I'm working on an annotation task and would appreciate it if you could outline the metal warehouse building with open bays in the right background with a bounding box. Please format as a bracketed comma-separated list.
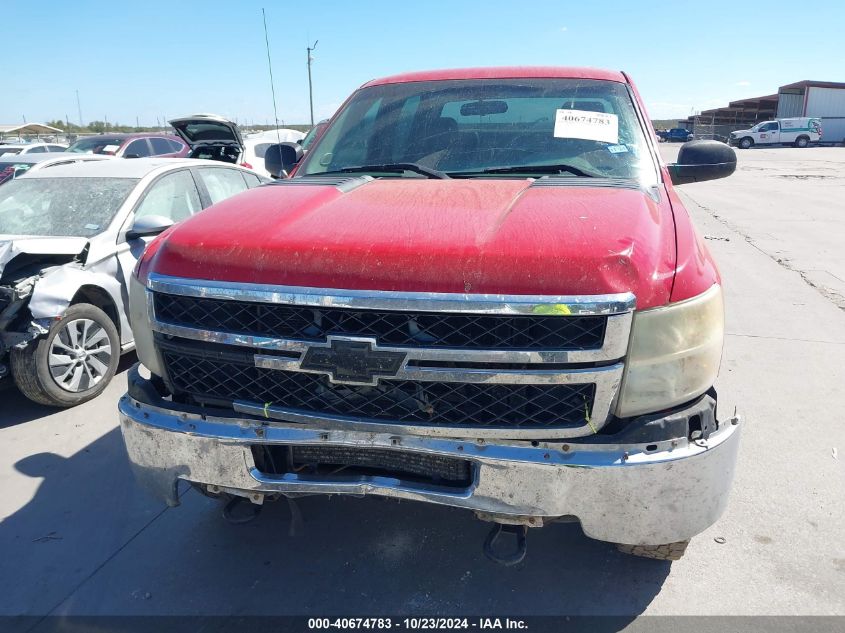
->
[678, 80, 845, 143]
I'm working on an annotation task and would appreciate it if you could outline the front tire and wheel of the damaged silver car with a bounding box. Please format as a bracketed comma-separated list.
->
[11, 303, 120, 407]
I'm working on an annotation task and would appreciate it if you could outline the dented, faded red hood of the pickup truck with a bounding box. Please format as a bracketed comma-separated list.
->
[150, 177, 675, 309]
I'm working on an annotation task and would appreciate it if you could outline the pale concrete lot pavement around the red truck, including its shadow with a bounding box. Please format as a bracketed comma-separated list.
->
[0, 147, 845, 616]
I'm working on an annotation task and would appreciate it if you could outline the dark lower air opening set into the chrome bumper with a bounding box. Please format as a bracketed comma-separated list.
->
[252, 444, 473, 487]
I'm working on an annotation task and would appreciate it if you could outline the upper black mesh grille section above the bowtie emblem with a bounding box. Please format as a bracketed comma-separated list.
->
[150, 293, 606, 350]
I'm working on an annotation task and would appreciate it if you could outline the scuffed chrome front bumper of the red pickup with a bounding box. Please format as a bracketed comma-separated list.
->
[119, 376, 740, 545]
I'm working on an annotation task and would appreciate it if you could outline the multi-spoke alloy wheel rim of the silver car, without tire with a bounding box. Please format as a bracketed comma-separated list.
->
[48, 319, 112, 393]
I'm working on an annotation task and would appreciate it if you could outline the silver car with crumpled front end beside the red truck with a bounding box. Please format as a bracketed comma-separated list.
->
[0, 158, 266, 407]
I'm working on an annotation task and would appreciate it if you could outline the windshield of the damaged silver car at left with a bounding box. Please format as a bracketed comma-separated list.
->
[0, 178, 138, 237]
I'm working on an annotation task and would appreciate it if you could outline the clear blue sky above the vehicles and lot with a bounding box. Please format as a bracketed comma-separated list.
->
[0, 0, 845, 125]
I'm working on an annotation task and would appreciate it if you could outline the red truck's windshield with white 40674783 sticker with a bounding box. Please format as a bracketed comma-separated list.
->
[297, 79, 657, 183]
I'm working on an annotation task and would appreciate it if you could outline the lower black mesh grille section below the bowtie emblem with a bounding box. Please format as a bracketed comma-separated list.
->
[162, 344, 595, 429]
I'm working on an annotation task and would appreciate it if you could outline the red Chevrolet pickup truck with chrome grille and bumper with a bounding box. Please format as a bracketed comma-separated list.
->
[119, 67, 740, 564]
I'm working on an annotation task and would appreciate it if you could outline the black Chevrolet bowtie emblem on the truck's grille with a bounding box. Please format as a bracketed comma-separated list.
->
[299, 338, 405, 385]
